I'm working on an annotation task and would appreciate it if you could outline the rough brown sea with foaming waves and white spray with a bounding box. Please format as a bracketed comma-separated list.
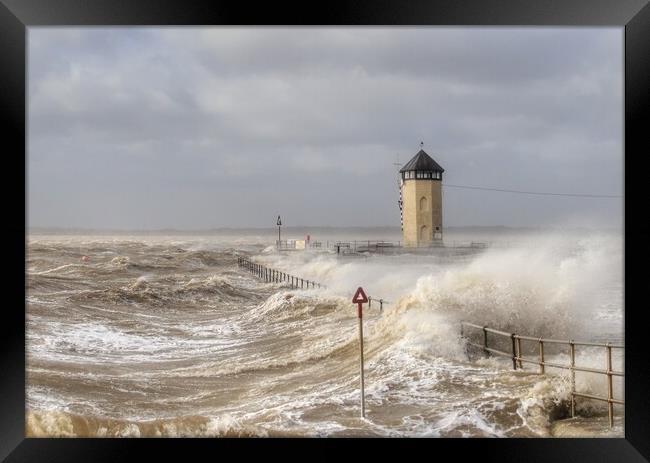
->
[27, 236, 623, 437]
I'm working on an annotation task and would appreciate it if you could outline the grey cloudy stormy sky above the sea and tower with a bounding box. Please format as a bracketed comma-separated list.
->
[27, 27, 623, 229]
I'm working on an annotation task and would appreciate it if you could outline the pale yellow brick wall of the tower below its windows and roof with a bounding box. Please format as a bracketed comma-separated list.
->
[402, 179, 442, 246]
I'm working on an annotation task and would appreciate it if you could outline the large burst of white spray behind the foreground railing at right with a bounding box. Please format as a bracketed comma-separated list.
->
[388, 234, 621, 336]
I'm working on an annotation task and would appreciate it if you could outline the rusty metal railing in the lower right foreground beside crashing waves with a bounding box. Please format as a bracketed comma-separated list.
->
[460, 321, 625, 428]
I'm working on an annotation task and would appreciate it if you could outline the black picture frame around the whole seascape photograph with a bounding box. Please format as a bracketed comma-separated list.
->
[0, 0, 650, 462]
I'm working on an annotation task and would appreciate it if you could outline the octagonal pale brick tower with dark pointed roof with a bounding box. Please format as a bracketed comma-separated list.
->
[400, 149, 445, 246]
